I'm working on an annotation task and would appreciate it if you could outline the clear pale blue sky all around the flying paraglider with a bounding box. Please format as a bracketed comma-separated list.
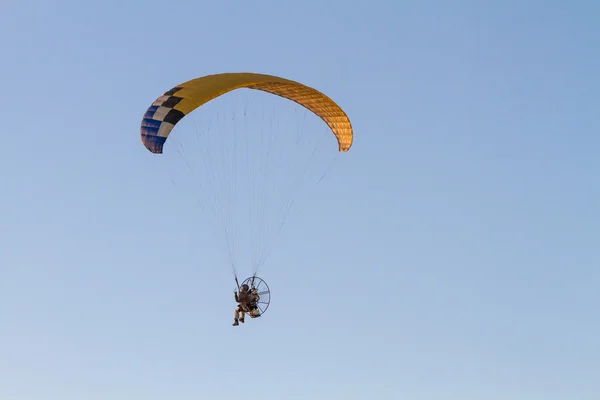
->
[0, 0, 600, 400]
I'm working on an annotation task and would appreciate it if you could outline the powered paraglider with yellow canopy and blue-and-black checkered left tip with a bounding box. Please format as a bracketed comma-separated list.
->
[140, 73, 353, 314]
